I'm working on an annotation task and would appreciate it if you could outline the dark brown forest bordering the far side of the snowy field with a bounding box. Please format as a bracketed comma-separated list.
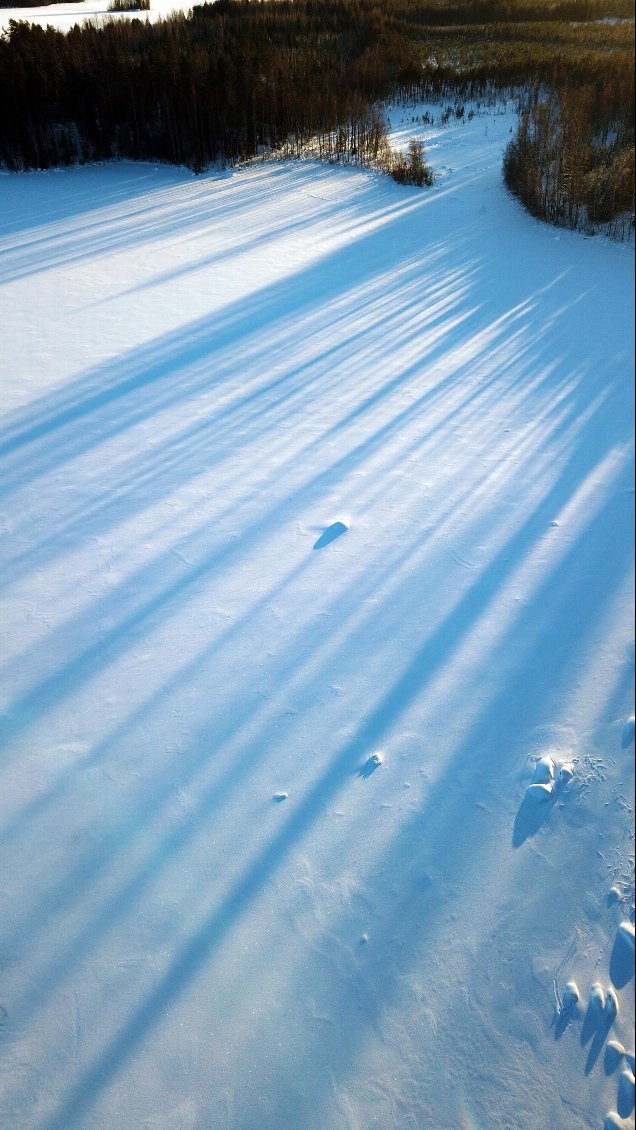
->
[0, 0, 634, 236]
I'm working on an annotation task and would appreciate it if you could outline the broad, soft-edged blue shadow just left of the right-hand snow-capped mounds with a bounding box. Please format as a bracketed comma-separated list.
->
[245, 467, 629, 1127]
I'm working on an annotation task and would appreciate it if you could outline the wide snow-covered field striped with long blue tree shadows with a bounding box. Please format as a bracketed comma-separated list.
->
[0, 101, 634, 1130]
